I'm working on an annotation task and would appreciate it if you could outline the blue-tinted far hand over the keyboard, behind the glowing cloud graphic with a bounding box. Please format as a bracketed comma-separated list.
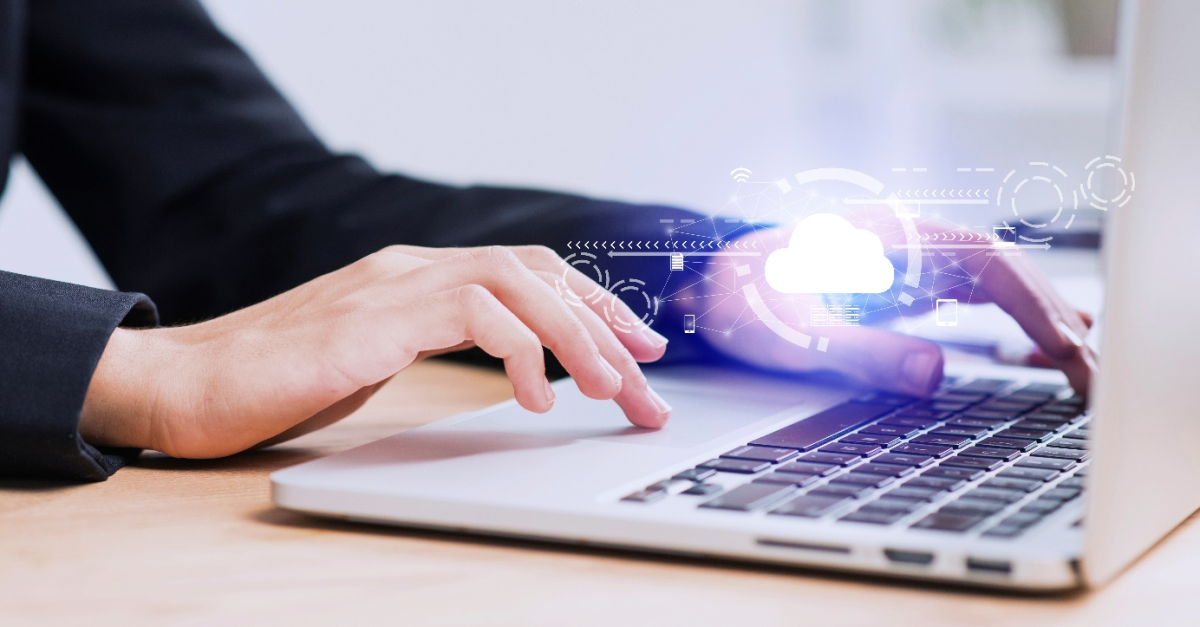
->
[692, 211, 1092, 396]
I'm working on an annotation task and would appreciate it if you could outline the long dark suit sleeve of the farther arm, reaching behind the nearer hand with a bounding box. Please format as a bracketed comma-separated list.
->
[22, 0, 691, 323]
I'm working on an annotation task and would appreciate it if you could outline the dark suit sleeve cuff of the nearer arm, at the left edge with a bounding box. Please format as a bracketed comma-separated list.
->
[0, 271, 156, 480]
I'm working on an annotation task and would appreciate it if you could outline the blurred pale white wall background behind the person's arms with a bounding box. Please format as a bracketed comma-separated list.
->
[0, 0, 1110, 285]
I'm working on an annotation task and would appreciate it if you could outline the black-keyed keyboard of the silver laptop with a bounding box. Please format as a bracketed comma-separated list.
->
[623, 378, 1090, 538]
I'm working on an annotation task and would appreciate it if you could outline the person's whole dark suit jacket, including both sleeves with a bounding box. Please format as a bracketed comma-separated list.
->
[0, 0, 691, 480]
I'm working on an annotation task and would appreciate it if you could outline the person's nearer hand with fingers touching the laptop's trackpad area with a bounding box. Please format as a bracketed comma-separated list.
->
[79, 246, 671, 458]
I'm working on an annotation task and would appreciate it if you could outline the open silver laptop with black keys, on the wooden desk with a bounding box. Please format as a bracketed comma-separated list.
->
[271, 1, 1200, 591]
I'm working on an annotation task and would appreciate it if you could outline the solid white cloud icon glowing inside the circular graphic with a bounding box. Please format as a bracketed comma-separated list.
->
[767, 214, 895, 294]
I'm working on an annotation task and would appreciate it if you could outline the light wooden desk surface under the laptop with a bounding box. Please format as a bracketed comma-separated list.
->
[0, 363, 1200, 626]
